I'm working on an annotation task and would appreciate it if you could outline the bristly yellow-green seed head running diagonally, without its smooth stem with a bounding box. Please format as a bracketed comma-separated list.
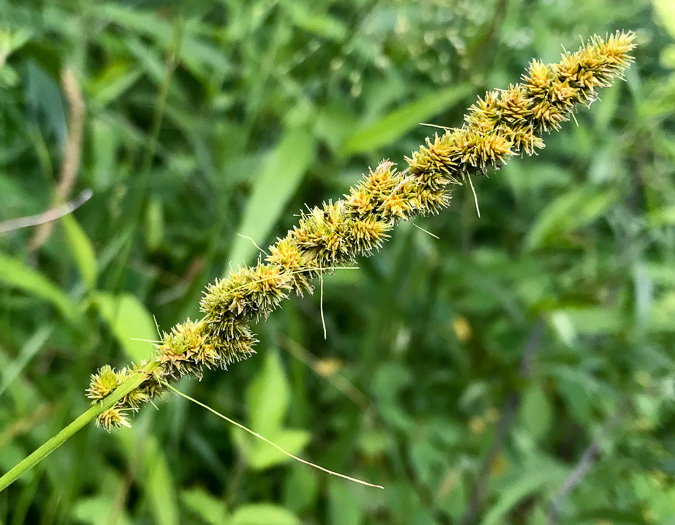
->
[87, 33, 634, 430]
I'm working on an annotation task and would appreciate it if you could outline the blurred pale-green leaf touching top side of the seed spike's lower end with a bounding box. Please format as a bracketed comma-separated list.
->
[94, 292, 159, 363]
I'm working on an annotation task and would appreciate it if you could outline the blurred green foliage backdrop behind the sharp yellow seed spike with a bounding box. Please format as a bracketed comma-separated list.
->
[0, 0, 675, 525]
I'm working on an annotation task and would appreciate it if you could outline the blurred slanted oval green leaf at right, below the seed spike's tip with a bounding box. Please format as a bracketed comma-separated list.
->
[527, 187, 617, 249]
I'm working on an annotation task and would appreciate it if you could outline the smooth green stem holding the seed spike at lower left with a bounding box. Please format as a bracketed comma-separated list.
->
[0, 362, 159, 492]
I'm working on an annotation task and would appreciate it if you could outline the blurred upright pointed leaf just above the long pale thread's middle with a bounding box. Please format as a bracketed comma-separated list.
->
[246, 350, 290, 439]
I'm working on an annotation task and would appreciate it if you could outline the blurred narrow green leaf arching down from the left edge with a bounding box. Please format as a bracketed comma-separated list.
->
[0, 253, 80, 324]
